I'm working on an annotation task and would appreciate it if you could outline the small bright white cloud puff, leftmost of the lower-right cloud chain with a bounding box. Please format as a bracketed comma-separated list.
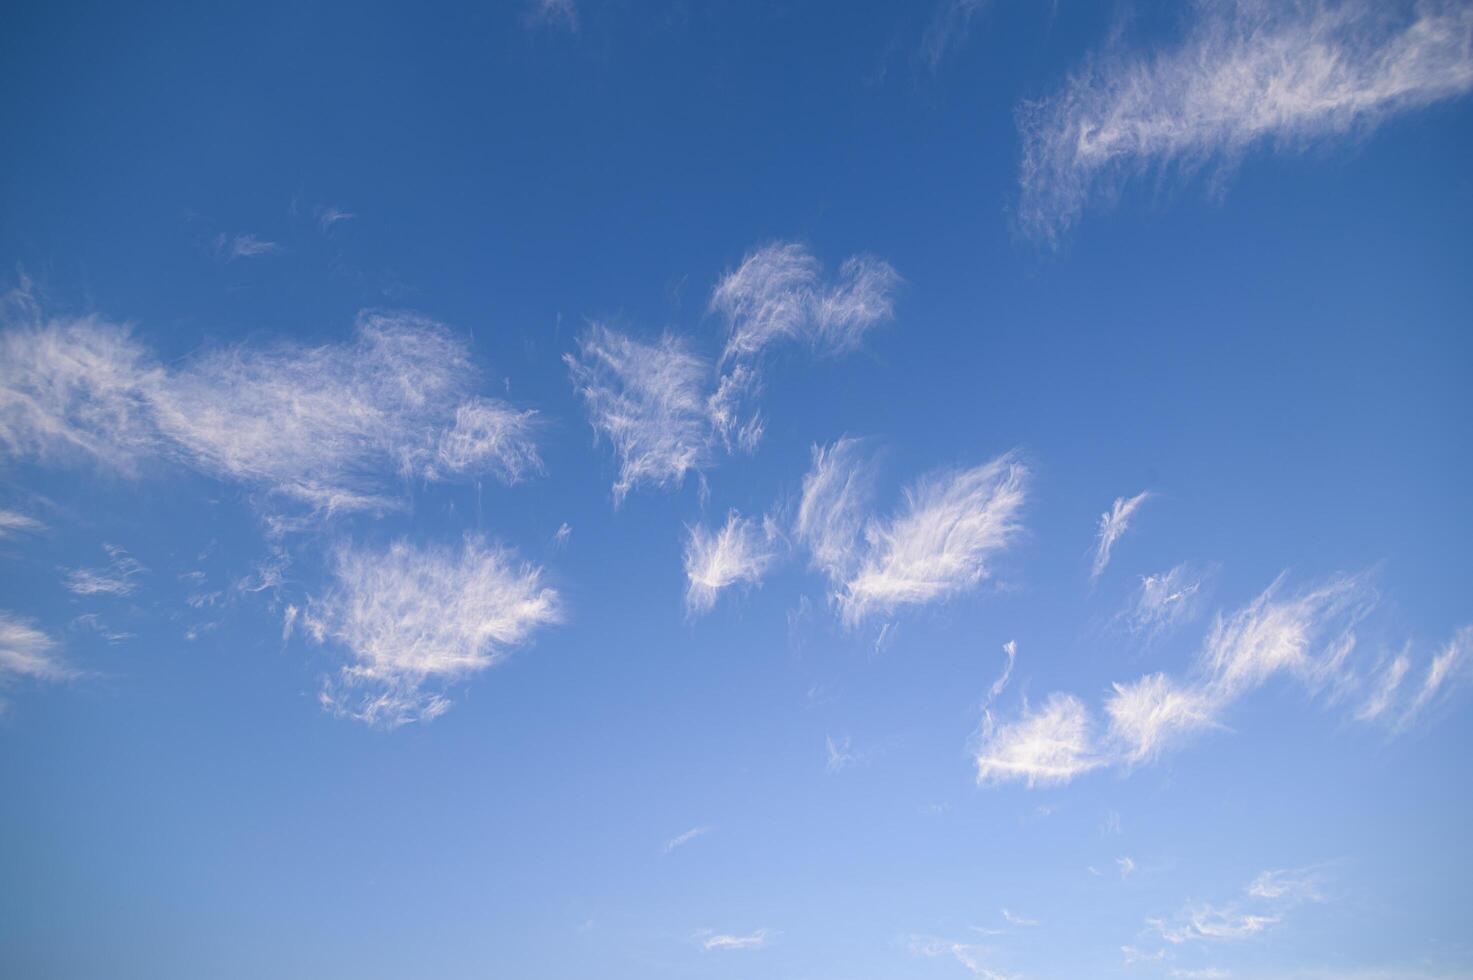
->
[977, 694, 1103, 787]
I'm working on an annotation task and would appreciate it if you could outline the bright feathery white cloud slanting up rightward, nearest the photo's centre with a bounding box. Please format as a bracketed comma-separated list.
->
[837, 454, 1028, 623]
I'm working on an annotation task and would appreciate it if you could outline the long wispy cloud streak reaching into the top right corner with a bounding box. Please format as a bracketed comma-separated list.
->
[1019, 0, 1473, 240]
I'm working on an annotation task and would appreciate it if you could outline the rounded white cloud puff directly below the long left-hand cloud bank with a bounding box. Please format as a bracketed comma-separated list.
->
[303, 536, 563, 728]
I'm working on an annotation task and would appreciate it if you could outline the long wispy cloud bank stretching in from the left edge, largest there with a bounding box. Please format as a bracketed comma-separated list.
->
[0, 300, 541, 513]
